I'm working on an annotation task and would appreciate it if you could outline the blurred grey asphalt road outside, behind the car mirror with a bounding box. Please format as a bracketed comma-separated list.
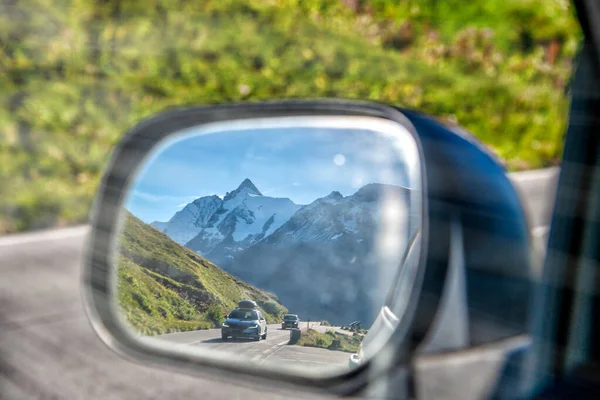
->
[0, 170, 556, 400]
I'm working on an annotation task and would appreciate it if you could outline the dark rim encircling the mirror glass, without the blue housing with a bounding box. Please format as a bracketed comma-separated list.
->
[83, 100, 427, 394]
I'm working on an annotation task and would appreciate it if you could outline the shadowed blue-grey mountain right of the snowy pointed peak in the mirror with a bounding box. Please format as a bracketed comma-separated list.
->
[227, 184, 408, 326]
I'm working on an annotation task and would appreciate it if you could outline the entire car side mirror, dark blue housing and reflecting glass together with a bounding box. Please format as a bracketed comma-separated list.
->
[84, 100, 531, 394]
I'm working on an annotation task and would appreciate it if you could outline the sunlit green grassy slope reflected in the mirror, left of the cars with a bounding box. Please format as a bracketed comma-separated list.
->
[118, 211, 287, 335]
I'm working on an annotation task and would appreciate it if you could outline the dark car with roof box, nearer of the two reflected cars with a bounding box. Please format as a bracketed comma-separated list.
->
[221, 308, 267, 340]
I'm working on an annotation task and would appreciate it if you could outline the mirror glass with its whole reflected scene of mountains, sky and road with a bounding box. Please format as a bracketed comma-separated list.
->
[116, 117, 422, 373]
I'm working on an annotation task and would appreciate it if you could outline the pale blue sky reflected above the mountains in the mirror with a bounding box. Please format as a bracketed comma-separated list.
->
[125, 122, 418, 223]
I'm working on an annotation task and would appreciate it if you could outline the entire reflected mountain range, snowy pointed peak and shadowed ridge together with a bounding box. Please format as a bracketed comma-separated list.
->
[153, 179, 414, 324]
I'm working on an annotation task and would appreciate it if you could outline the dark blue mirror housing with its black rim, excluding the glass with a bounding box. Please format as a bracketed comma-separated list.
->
[84, 100, 531, 394]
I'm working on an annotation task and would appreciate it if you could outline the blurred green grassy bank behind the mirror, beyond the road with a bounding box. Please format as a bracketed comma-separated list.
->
[0, 0, 581, 233]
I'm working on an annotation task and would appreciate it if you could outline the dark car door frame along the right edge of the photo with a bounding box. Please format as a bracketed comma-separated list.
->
[527, 0, 600, 398]
